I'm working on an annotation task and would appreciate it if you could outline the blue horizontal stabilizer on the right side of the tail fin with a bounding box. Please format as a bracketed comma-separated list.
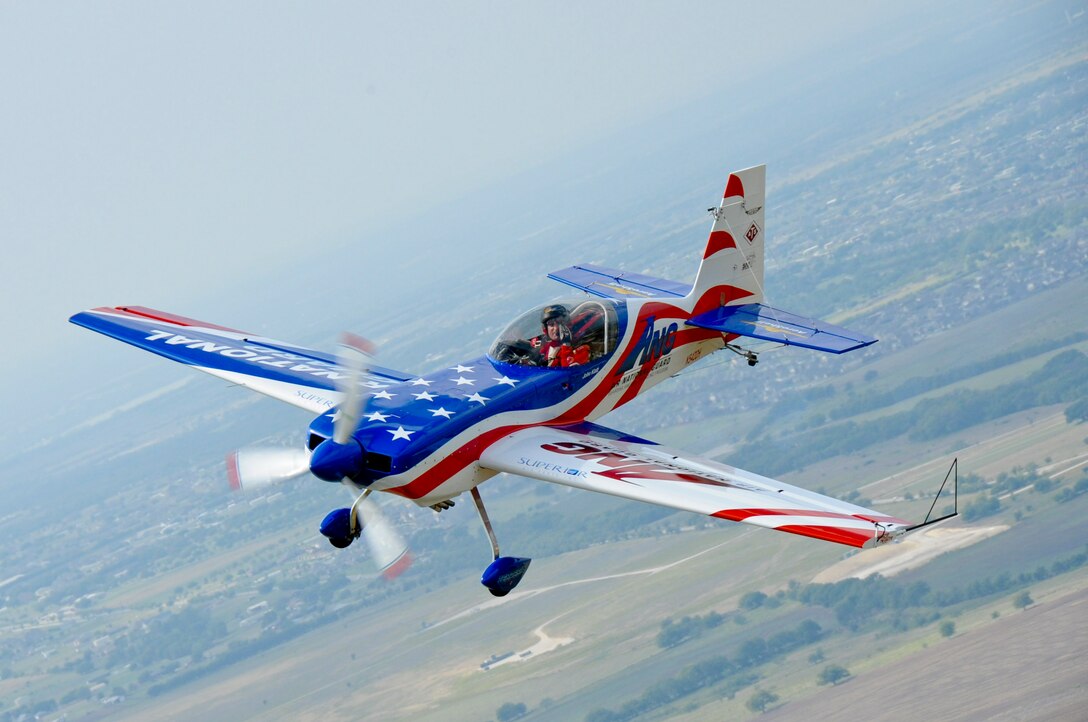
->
[688, 303, 877, 353]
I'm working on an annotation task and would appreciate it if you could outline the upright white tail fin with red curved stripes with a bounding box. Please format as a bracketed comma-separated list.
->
[688, 165, 767, 313]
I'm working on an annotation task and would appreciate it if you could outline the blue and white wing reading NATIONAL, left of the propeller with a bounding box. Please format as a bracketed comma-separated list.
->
[70, 306, 412, 413]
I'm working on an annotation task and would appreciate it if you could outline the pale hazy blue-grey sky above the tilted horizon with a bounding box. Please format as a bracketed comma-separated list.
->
[0, 0, 948, 377]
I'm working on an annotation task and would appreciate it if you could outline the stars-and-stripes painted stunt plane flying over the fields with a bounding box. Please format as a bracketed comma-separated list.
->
[71, 165, 931, 596]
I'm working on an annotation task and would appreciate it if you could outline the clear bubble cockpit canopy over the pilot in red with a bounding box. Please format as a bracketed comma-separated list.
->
[487, 298, 623, 369]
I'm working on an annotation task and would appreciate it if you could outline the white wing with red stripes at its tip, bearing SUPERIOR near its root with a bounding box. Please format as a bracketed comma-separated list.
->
[480, 424, 911, 547]
